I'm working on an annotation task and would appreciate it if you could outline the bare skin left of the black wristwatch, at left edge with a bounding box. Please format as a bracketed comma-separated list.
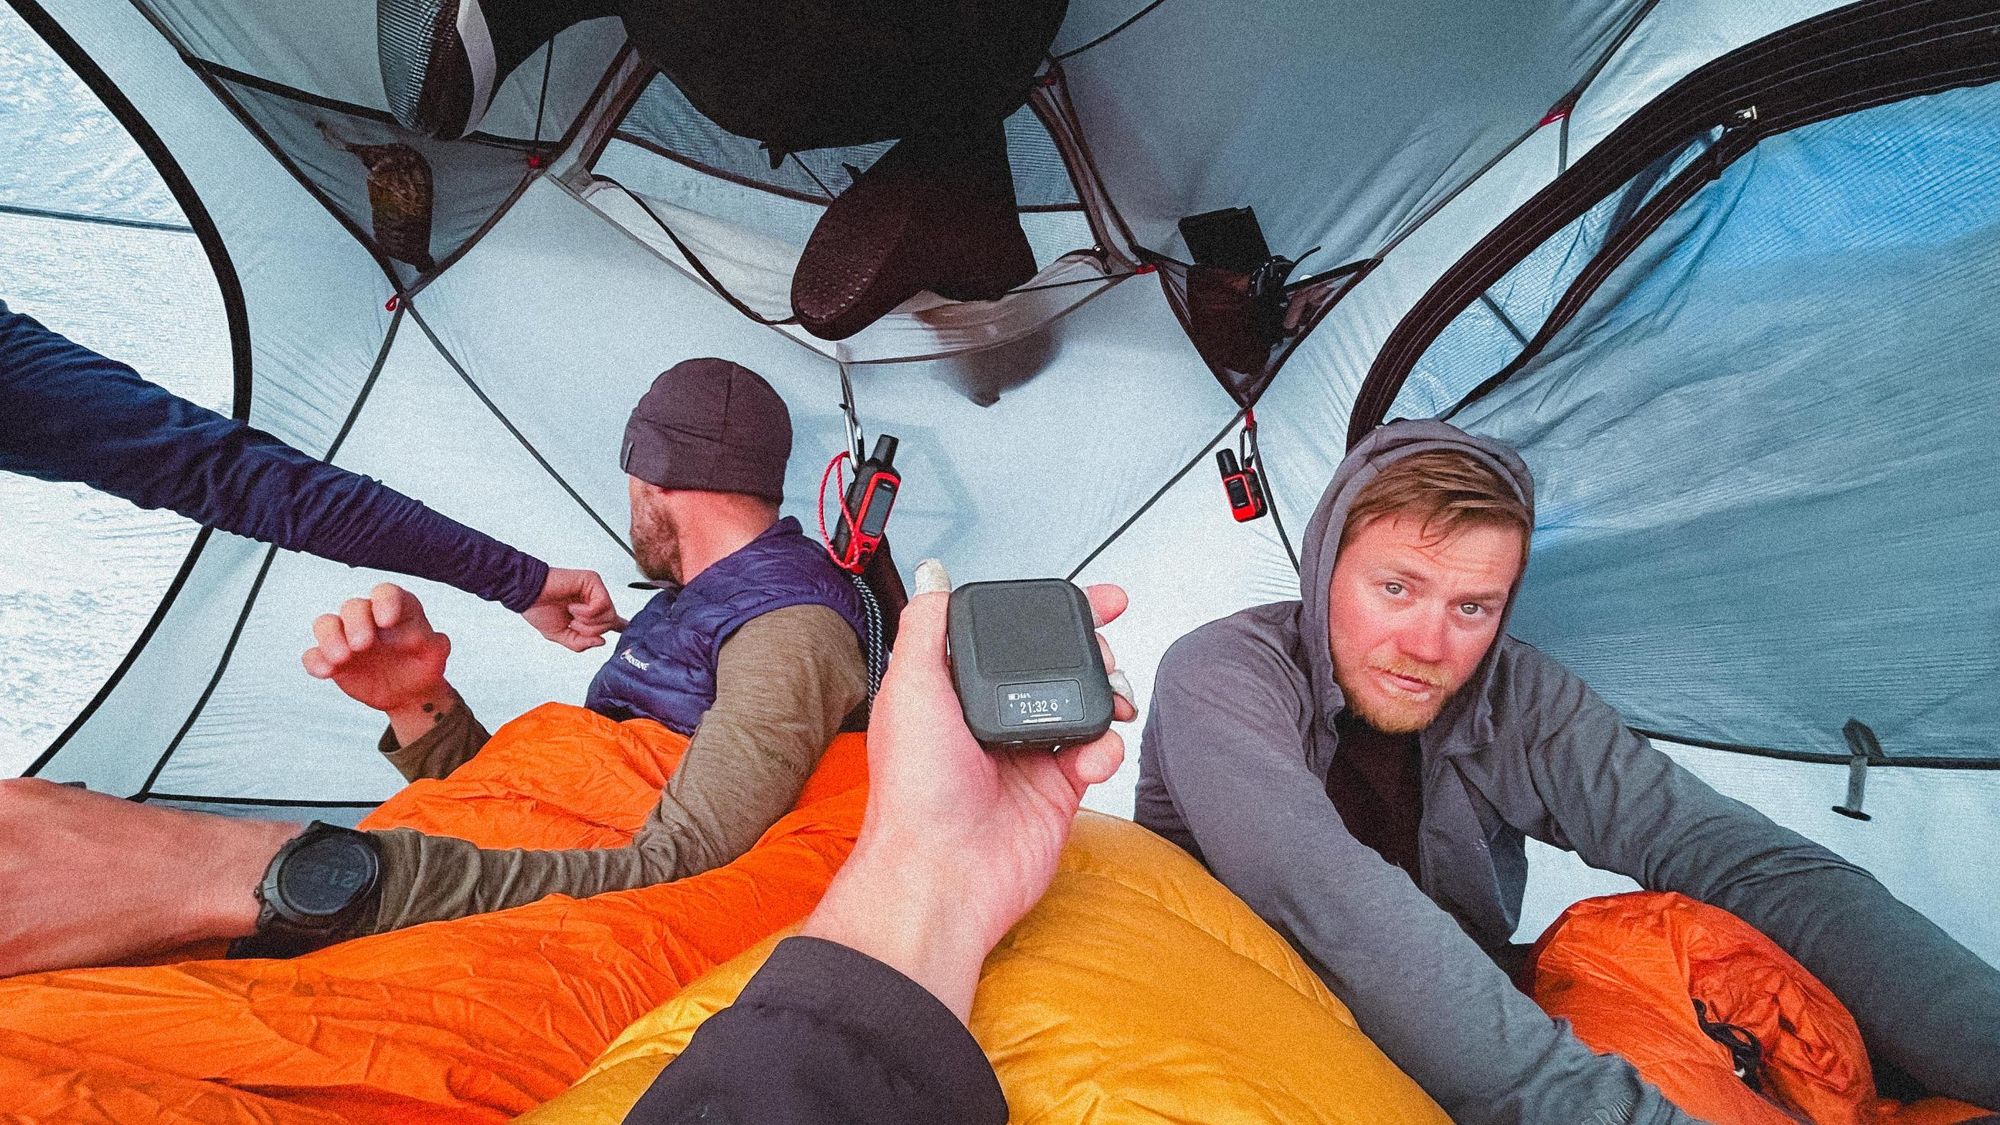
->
[0, 779, 302, 977]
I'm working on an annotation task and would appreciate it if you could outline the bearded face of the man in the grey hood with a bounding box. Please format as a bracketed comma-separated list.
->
[1326, 514, 1522, 735]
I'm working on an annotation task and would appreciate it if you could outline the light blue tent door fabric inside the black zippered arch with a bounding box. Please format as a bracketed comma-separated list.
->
[1394, 86, 2000, 763]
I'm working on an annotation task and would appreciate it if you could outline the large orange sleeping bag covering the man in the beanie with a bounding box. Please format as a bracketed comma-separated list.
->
[0, 705, 868, 1125]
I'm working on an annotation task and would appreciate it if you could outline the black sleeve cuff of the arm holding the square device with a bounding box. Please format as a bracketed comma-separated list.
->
[626, 937, 1008, 1125]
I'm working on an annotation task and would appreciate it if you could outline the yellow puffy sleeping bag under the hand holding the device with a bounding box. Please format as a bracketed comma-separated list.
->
[520, 813, 1450, 1125]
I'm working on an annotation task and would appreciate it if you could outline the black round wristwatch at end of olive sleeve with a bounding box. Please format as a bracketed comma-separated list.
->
[230, 821, 382, 957]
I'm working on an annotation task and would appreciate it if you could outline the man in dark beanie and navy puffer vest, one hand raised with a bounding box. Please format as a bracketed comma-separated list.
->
[292, 358, 868, 937]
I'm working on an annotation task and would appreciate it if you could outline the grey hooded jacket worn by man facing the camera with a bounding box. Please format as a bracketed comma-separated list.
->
[1136, 420, 2000, 1125]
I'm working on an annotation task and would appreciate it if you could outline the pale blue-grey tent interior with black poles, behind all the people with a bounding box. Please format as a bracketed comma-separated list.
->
[0, 0, 2000, 961]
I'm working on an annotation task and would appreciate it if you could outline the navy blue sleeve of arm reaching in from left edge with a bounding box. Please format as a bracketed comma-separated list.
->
[0, 302, 548, 613]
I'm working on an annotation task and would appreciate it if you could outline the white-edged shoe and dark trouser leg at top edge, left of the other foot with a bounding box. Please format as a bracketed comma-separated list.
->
[376, 0, 614, 140]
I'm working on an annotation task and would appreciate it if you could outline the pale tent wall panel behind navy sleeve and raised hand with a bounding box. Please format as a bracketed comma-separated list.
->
[148, 318, 636, 807]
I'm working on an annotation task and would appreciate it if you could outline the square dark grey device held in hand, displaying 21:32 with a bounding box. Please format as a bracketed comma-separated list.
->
[946, 579, 1112, 751]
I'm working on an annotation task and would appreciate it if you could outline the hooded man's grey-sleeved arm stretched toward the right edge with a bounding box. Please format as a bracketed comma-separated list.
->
[1530, 656, 2000, 1109]
